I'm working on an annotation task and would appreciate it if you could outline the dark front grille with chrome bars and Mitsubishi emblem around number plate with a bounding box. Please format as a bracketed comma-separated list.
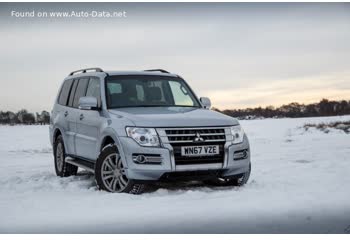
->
[165, 128, 226, 165]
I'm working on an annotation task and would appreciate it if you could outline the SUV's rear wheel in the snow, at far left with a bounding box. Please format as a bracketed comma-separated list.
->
[54, 135, 78, 177]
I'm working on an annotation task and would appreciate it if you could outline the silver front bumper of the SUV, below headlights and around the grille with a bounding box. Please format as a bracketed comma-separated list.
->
[120, 136, 250, 181]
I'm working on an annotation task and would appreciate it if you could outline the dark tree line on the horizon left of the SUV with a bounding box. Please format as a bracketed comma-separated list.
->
[0, 109, 50, 125]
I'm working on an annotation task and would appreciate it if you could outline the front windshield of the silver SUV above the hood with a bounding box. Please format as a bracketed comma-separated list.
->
[106, 75, 200, 108]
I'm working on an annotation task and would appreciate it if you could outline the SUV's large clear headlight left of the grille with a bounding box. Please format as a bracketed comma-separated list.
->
[126, 127, 159, 147]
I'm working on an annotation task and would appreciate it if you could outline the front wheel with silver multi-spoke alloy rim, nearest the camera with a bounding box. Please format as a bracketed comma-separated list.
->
[95, 145, 146, 194]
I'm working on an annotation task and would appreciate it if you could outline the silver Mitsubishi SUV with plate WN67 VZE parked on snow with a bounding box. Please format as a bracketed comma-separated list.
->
[50, 68, 251, 194]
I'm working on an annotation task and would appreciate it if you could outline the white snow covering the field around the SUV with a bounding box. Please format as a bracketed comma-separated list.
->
[0, 116, 350, 233]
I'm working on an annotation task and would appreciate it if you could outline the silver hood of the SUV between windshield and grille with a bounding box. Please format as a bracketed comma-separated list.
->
[109, 107, 238, 127]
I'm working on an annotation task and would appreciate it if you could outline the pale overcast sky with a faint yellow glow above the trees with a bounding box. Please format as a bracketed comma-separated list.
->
[0, 3, 350, 111]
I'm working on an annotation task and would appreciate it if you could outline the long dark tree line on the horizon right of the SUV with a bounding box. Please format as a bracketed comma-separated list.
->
[213, 99, 350, 119]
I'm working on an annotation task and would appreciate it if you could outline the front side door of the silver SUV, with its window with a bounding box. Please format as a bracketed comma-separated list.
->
[76, 77, 103, 160]
